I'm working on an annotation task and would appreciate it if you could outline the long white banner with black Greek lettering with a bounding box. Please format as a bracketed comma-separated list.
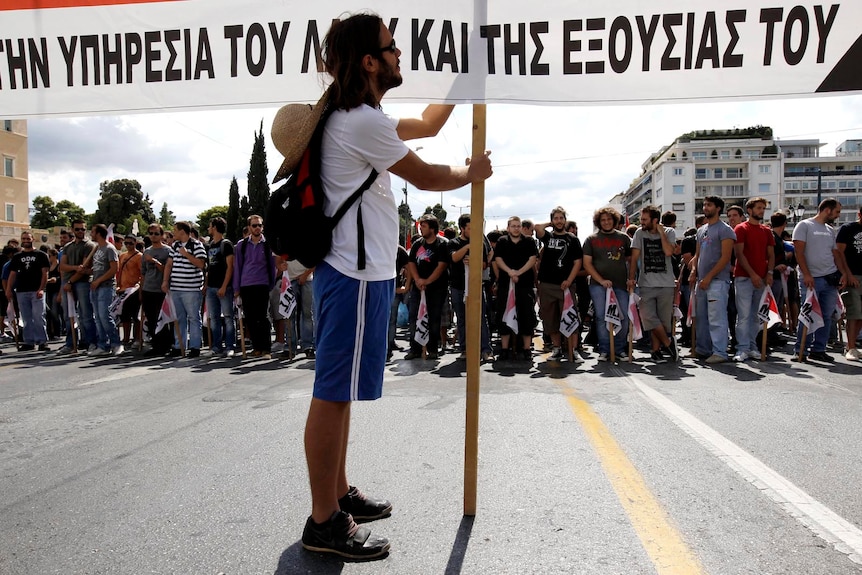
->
[0, 0, 862, 118]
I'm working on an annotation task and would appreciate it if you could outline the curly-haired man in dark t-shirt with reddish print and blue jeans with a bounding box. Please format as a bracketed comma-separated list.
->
[584, 207, 631, 361]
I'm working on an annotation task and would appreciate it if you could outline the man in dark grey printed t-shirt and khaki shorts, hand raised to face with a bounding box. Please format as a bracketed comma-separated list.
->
[628, 206, 679, 363]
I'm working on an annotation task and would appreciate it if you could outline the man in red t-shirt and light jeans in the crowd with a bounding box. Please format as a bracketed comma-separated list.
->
[733, 198, 775, 362]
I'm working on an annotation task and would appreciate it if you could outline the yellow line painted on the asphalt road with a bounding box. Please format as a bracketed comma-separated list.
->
[558, 381, 706, 575]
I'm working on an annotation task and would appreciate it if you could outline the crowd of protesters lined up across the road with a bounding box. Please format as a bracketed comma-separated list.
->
[0, 196, 862, 364]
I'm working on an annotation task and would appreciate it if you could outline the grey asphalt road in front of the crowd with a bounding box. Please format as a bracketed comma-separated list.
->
[0, 338, 862, 575]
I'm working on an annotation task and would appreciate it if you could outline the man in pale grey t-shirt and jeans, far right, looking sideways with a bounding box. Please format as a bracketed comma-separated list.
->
[793, 198, 848, 361]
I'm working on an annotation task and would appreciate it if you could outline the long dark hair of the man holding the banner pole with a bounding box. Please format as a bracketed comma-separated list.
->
[321, 14, 382, 110]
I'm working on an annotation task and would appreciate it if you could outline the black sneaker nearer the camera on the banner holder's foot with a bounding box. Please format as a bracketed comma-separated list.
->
[302, 511, 389, 559]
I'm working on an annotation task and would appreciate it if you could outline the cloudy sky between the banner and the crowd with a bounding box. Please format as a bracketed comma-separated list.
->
[28, 95, 862, 230]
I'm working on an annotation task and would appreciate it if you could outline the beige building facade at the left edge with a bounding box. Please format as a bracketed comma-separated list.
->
[0, 120, 30, 245]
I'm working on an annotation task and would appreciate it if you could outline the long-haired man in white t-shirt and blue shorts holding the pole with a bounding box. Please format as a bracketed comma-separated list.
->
[273, 14, 491, 559]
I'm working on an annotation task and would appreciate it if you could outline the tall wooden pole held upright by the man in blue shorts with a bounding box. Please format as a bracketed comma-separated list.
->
[464, 104, 487, 516]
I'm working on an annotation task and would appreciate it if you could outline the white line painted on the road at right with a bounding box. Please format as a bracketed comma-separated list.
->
[629, 376, 862, 563]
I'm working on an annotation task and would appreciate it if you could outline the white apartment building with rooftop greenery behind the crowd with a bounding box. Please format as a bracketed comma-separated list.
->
[622, 126, 862, 230]
